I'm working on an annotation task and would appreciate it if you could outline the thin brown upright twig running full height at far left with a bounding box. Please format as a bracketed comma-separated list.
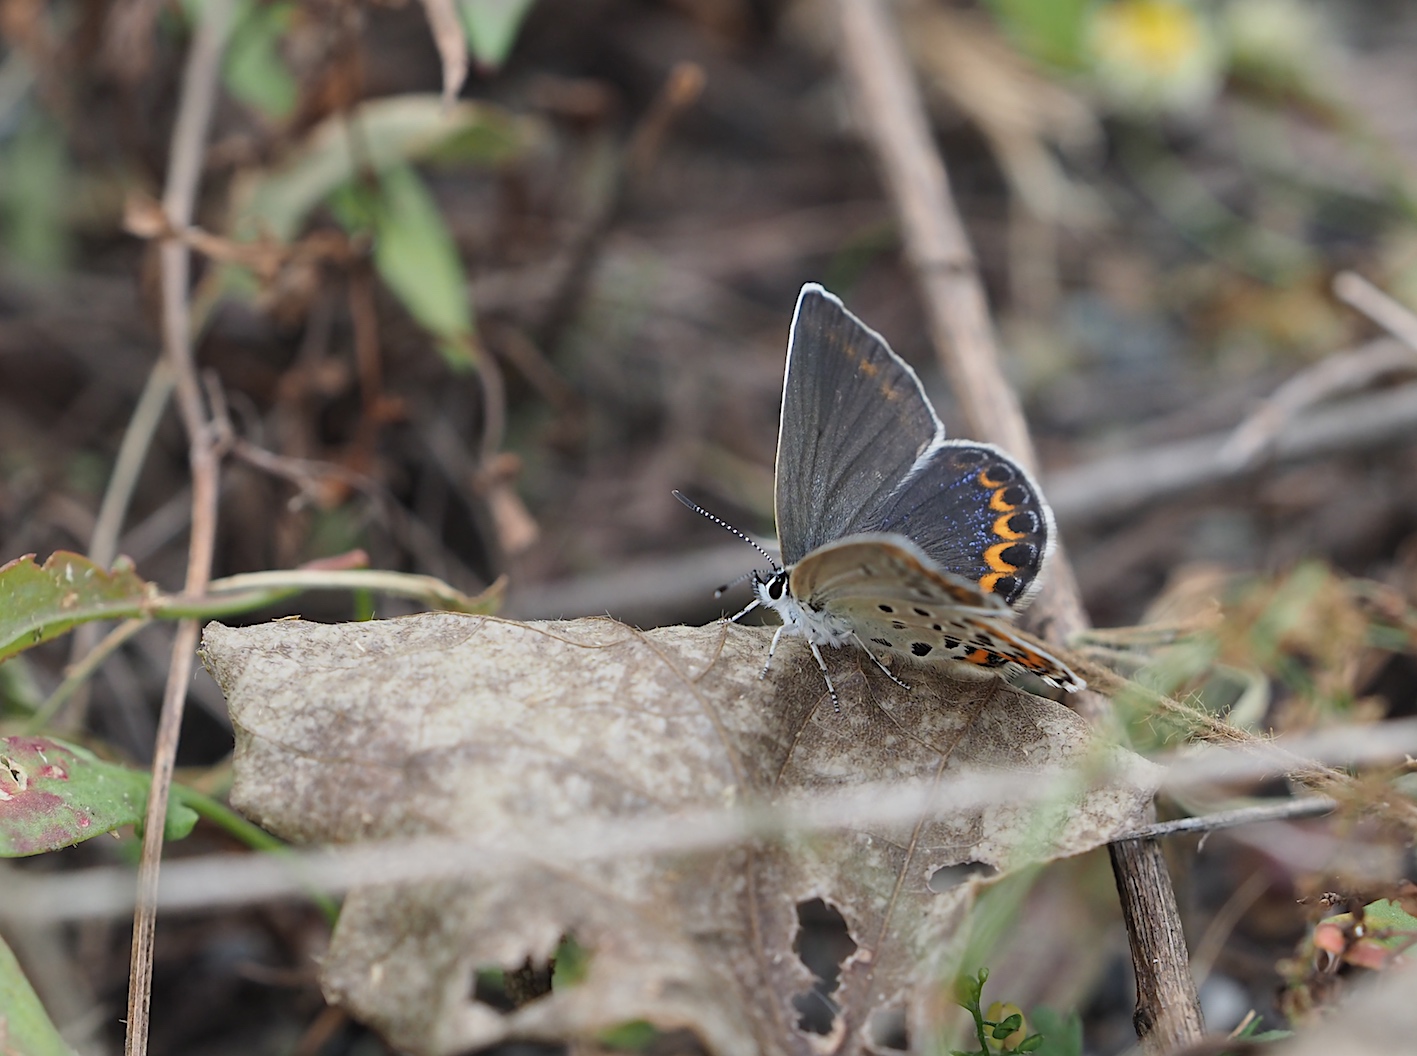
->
[123, 0, 234, 1056]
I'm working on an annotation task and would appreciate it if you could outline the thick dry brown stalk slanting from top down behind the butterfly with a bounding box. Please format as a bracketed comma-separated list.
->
[836, 0, 1204, 1052]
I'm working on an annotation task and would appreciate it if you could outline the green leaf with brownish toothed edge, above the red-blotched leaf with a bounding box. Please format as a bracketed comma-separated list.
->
[0, 550, 156, 661]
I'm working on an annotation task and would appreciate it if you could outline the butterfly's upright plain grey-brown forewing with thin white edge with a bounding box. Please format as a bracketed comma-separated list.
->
[775, 283, 944, 564]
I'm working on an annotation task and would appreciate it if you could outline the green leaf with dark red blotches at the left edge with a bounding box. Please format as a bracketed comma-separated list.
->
[0, 737, 197, 858]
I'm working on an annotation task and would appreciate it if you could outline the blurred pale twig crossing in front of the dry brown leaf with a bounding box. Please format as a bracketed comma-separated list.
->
[13, 720, 1417, 920]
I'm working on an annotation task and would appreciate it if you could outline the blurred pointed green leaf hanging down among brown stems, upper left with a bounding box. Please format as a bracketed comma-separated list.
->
[362, 164, 476, 369]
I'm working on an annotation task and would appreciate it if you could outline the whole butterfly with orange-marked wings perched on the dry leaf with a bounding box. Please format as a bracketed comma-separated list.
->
[680, 283, 1085, 707]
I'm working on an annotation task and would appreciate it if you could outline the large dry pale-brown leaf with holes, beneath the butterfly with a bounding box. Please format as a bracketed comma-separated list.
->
[203, 614, 1156, 1056]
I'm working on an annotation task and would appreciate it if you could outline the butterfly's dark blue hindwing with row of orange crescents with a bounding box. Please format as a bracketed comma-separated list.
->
[863, 441, 1054, 610]
